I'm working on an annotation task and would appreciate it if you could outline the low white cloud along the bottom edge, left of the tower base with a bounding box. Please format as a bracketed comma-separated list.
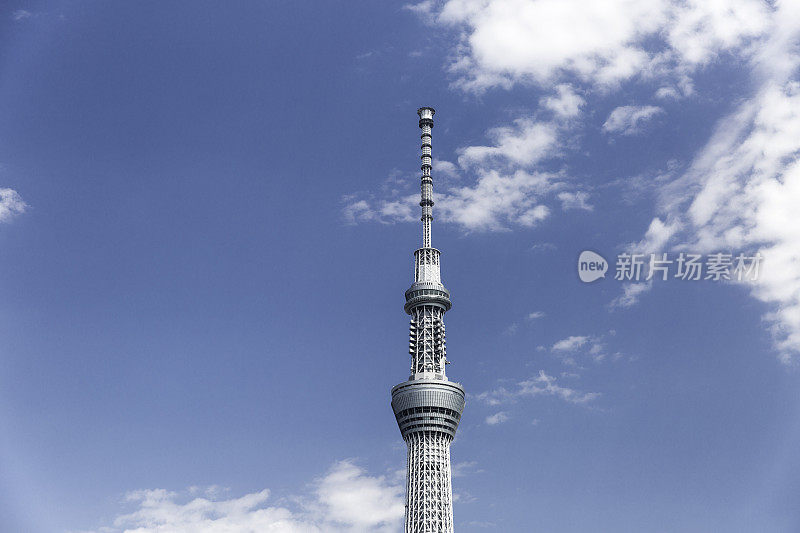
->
[84, 461, 404, 533]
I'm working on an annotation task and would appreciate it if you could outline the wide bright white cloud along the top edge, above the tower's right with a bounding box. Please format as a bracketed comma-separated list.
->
[410, 0, 770, 92]
